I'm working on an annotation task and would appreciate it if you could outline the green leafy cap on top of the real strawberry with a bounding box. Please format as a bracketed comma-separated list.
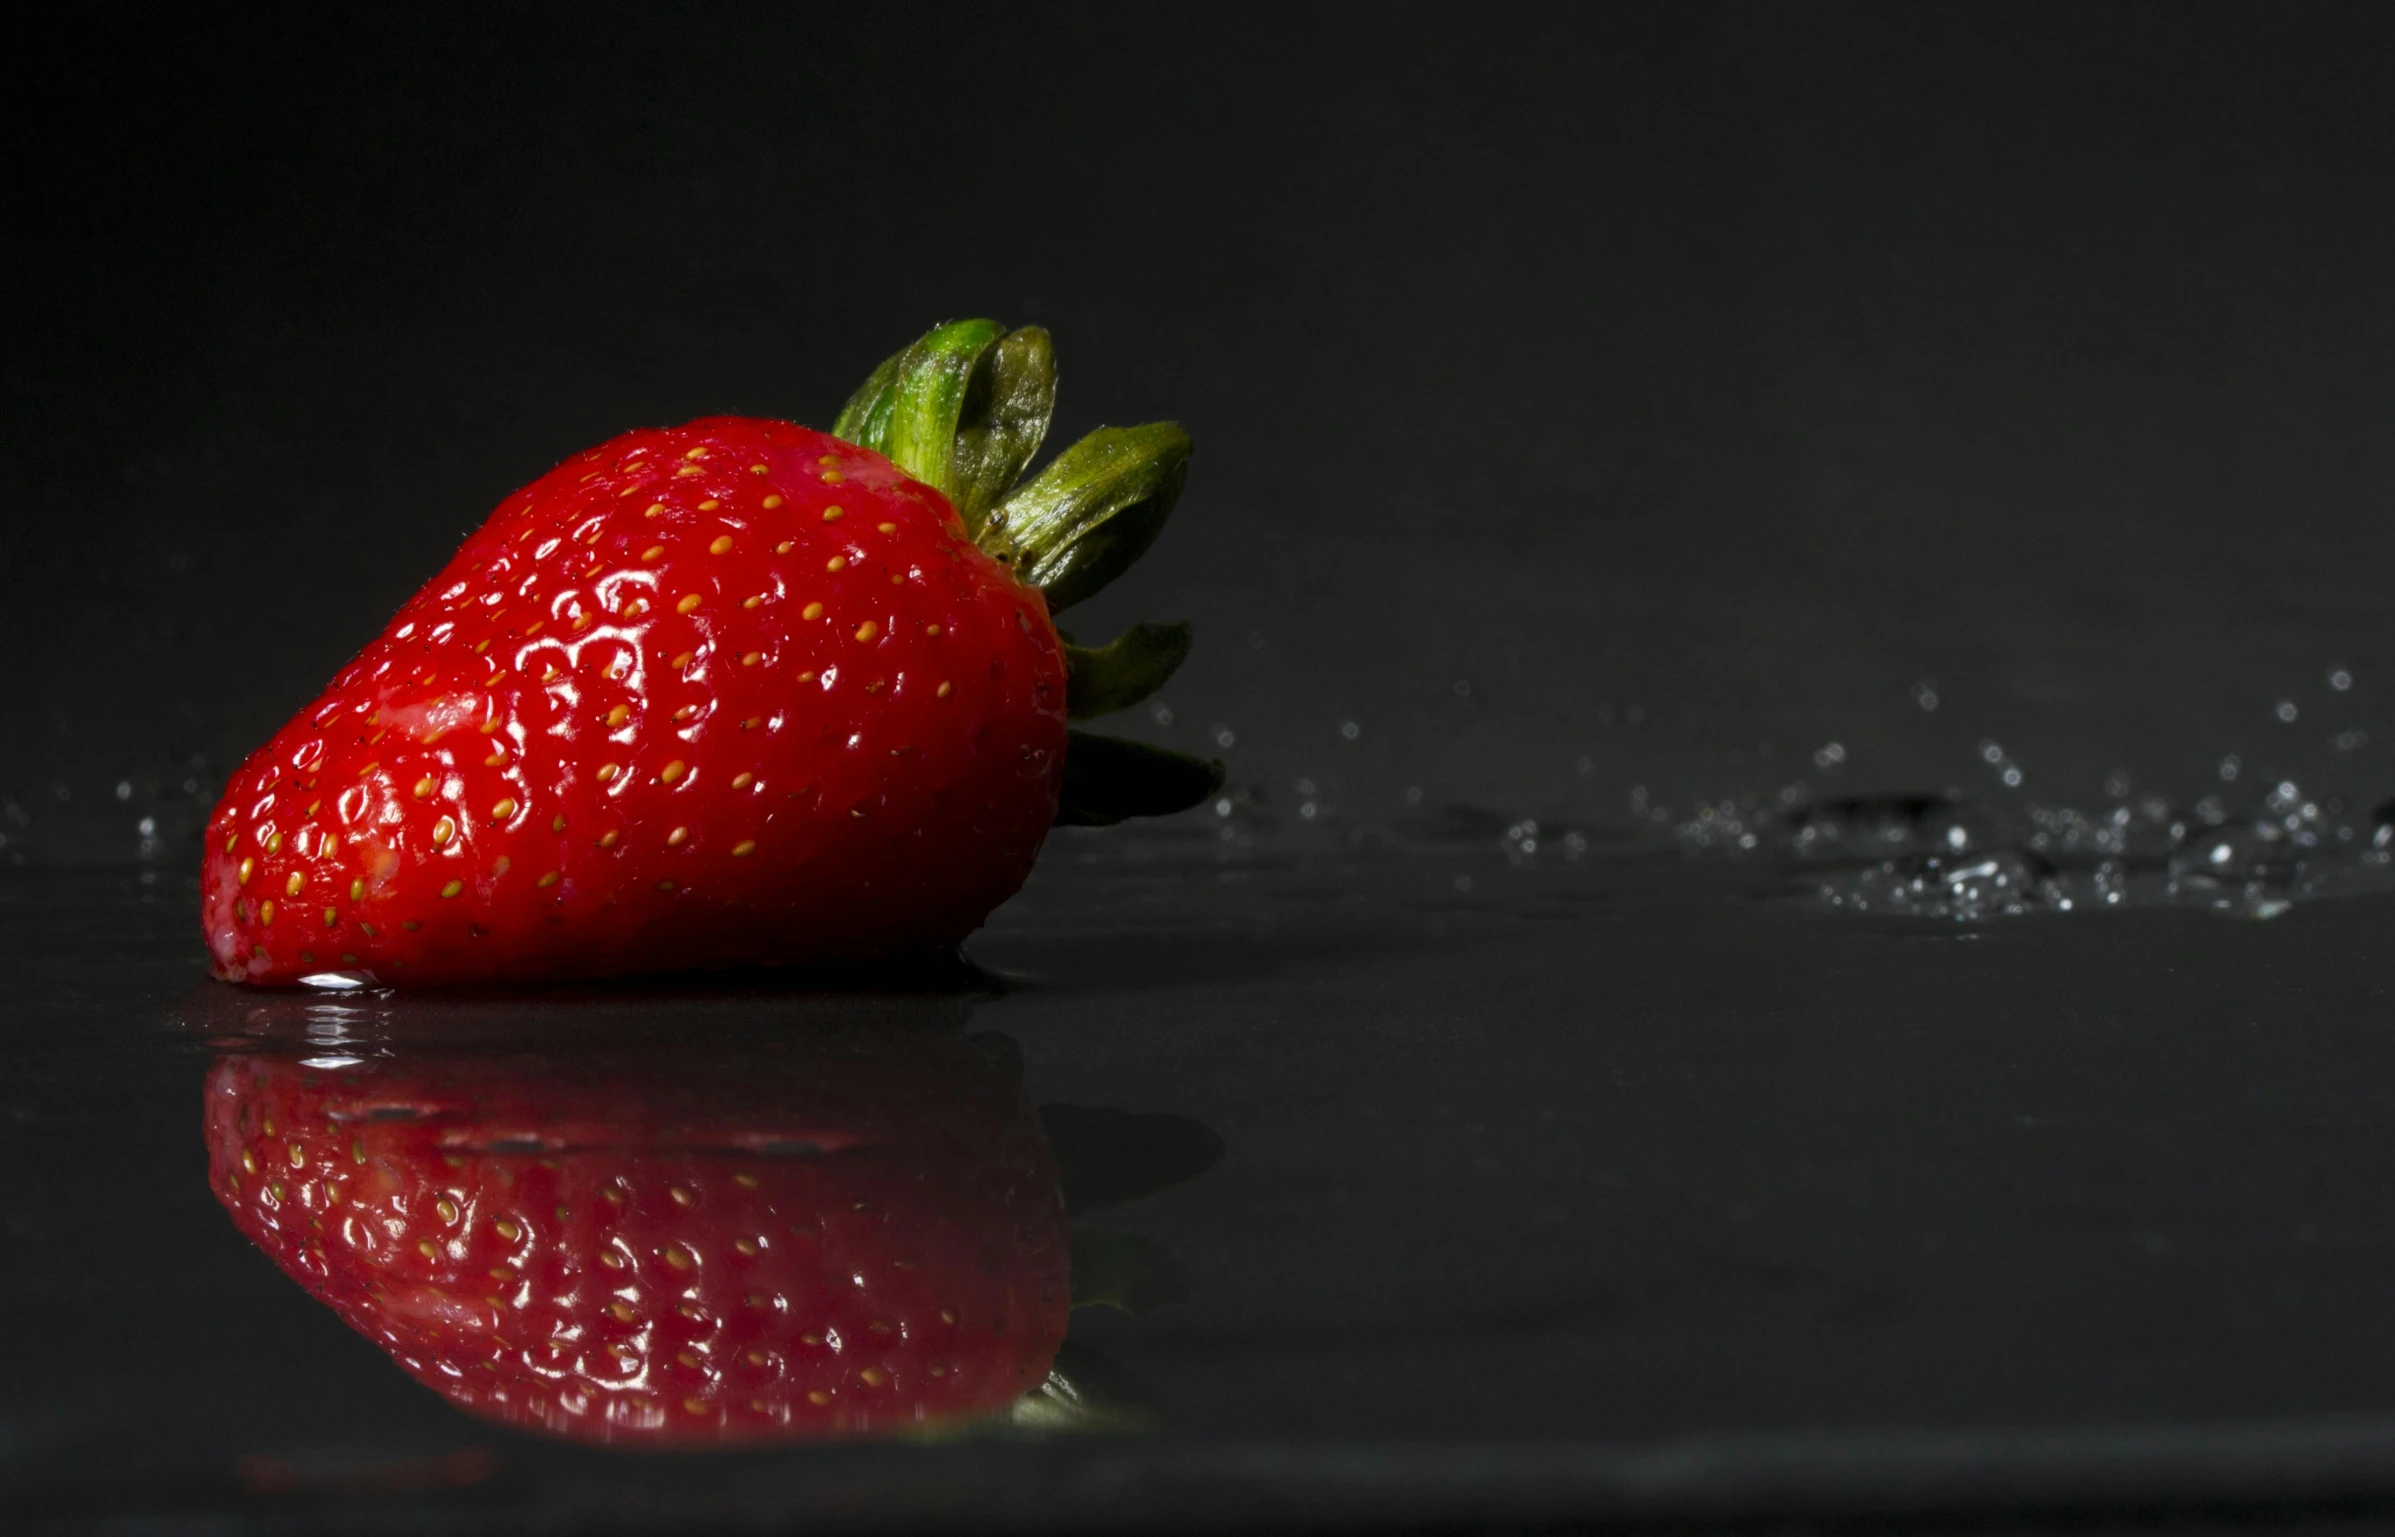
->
[831, 321, 1221, 826]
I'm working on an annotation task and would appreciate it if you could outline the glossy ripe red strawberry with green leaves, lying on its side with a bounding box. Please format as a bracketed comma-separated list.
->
[201, 321, 1221, 984]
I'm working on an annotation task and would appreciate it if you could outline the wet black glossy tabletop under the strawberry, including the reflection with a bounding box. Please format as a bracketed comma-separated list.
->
[23, 812, 2395, 1530]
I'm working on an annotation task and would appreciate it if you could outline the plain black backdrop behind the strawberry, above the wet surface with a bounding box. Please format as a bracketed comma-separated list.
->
[14, 5, 2395, 862]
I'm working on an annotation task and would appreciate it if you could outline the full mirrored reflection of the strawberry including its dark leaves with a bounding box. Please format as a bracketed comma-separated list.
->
[172, 967, 1221, 1448]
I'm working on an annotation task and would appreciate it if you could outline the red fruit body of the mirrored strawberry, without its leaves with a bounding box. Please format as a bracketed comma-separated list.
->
[206, 1027, 1071, 1446]
